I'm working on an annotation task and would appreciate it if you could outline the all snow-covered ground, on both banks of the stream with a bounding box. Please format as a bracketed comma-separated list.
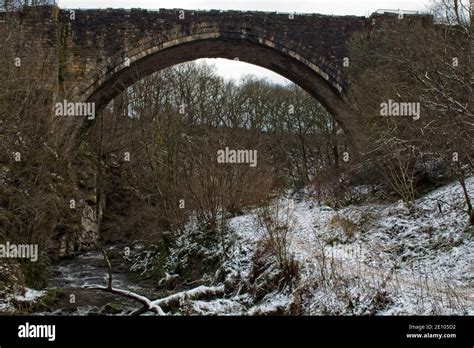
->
[0, 177, 474, 315]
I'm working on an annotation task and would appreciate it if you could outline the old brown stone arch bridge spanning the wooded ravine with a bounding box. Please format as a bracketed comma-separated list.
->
[0, 6, 430, 147]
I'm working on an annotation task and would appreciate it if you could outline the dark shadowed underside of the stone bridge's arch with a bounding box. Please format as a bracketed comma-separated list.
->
[78, 37, 351, 143]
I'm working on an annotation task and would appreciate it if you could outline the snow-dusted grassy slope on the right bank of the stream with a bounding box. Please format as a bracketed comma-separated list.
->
[204, 177, 474, 315]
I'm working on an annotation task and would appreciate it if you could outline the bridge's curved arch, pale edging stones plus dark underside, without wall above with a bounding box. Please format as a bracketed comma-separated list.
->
[75, 27, 355, 145]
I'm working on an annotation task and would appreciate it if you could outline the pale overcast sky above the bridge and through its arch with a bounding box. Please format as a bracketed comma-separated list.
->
[57, 0, 430, 83]
